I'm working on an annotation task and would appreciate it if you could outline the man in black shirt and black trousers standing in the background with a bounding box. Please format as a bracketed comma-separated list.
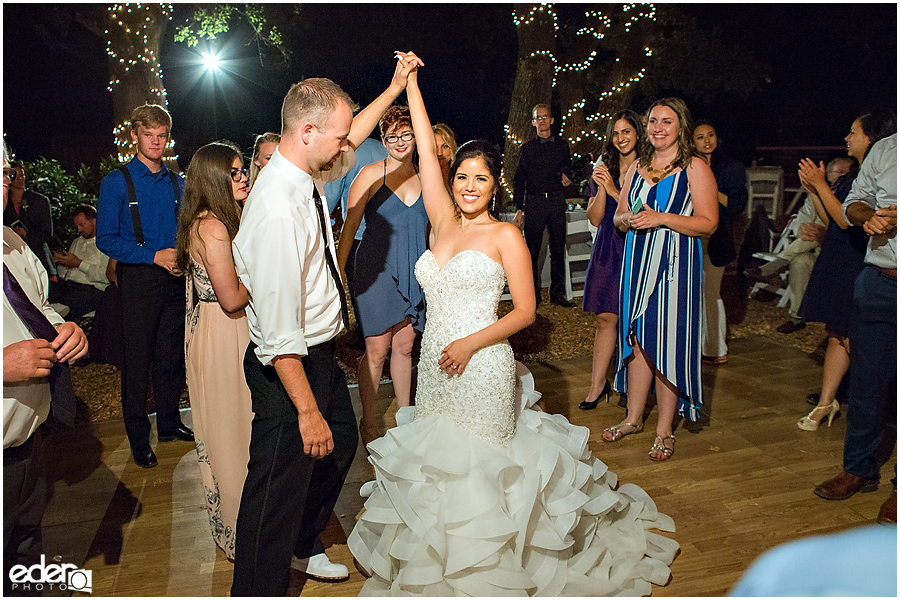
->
[513, 104, 574, 308]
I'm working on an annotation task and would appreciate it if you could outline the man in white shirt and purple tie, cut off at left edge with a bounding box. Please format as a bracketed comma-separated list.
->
[3, 144, 87, 595]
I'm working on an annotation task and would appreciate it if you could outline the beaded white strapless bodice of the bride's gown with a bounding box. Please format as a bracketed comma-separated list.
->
[415, 250, 515, 444]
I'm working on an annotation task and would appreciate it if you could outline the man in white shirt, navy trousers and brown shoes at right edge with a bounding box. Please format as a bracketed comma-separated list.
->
[815, 131, 897, 525]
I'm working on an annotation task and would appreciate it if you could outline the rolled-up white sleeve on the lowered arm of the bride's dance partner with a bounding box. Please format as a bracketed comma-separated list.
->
[233, 211, 313, 365]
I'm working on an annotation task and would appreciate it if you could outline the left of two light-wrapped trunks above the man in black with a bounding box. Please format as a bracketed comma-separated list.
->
[503, 4, 556, 206]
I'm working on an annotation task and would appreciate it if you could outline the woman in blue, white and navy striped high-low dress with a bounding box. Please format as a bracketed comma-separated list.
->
[603, 98, 718, 461]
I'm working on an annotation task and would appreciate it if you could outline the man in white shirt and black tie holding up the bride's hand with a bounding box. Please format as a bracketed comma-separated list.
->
[231, 55, 417, 596]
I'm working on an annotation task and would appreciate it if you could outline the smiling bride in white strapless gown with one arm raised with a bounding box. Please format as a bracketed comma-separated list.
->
[348, 53, 678, 596]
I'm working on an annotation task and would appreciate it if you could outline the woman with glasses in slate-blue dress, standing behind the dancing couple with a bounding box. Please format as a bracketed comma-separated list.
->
[338, 106, 428, 443]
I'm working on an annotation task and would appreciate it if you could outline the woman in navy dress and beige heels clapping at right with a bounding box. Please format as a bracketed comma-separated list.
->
[797, 114, 896, 431]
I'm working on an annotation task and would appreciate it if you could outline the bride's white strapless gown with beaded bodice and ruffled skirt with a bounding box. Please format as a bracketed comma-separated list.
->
[348, 252, 678, 596]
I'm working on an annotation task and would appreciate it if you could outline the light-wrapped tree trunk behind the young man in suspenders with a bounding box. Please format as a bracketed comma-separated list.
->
[106, 4, 180, 171]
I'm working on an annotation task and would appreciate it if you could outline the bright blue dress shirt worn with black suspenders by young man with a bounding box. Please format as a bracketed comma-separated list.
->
[97, 156, 184, 264]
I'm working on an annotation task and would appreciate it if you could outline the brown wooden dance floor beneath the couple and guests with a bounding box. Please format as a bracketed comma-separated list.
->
[38, 337, 896, 596]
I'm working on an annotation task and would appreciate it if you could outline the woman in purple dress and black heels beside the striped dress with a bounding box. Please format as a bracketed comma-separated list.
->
[578, 110, 644, 410]
